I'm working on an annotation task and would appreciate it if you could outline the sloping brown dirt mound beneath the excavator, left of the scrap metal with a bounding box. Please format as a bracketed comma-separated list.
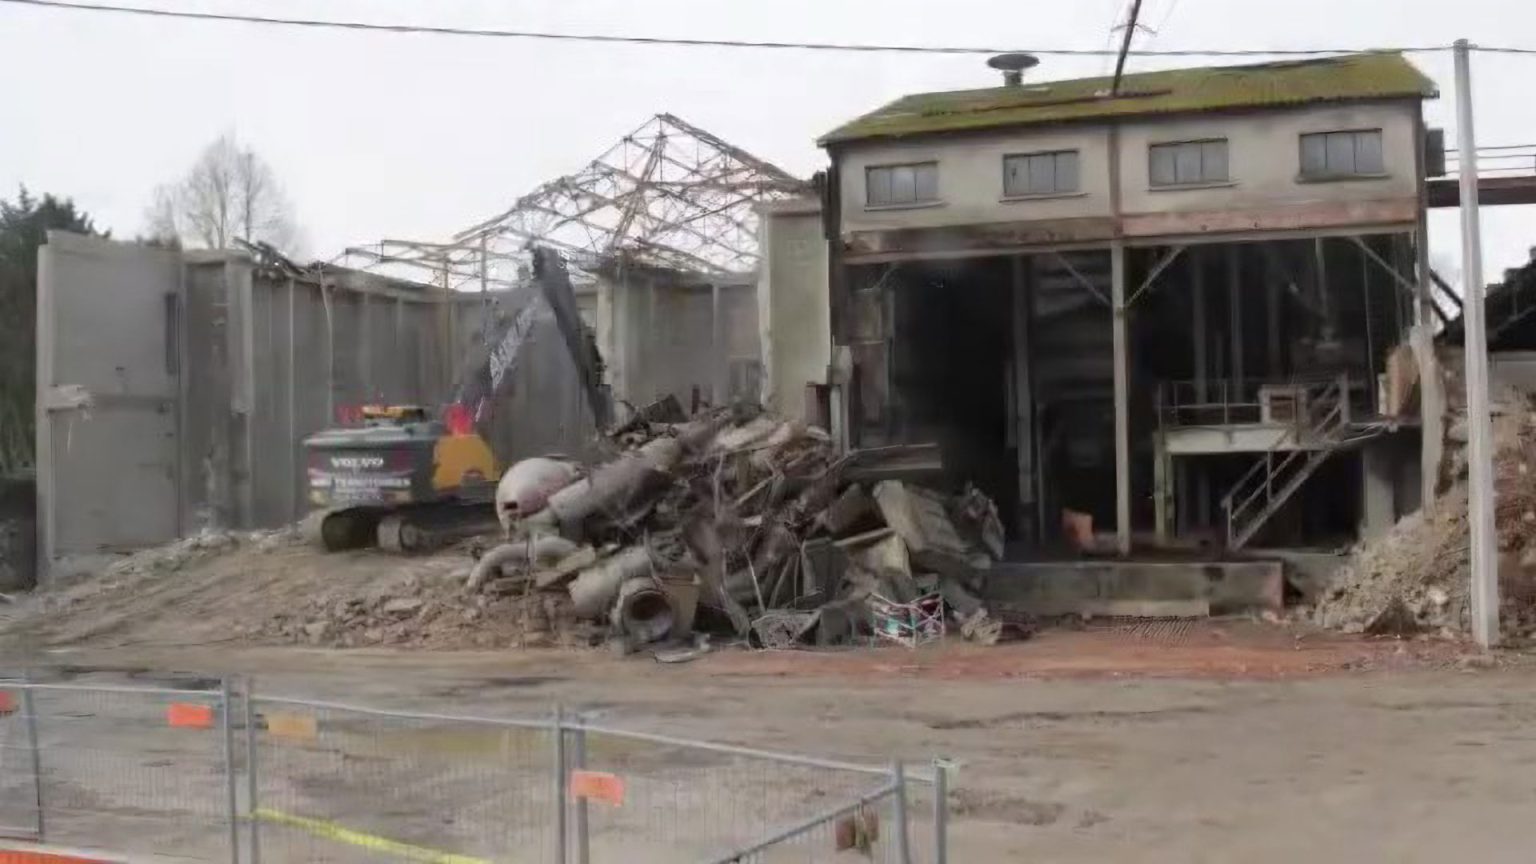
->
[0, 530, 581, 649]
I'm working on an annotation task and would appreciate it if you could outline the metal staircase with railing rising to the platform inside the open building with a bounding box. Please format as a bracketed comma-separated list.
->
[1221, 378, 1349, 549]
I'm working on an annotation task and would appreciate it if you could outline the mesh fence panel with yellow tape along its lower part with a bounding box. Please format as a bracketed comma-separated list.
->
[244, 696, 556, 864]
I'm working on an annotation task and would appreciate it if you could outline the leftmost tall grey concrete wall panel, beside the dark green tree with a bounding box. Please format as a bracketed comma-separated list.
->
[37, 232, 181, 580]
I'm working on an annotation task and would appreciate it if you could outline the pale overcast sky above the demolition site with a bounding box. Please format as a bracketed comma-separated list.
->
[0, 0, 1536, 280]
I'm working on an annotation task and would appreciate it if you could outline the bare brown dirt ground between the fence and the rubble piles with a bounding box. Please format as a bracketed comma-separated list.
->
[6, 621, 1536, 864]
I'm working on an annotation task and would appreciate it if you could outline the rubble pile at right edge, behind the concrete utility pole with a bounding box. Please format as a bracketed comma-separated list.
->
[1313, 397, 1536, 638]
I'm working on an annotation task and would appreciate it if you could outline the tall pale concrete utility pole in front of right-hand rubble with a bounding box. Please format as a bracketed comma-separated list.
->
[1456, 38, 1499, 647]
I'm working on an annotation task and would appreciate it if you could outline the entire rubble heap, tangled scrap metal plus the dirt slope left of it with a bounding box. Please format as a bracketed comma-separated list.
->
[6, 404, 1029, 651]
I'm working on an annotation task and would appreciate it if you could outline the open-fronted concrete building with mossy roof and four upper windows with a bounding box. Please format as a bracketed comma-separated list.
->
[759, 54, 1444, 553]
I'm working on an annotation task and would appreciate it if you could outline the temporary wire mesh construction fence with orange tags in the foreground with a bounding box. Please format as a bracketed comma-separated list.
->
[0, 680, 948, 864]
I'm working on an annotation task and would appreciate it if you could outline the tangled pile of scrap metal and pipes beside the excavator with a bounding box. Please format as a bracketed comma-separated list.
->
[465, 400, 1028, 650]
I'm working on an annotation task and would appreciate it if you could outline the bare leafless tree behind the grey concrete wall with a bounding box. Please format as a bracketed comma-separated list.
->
[146, 132, 298, 251]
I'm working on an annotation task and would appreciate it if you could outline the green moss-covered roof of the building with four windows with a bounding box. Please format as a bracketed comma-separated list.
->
[820, 52, 1439, 145]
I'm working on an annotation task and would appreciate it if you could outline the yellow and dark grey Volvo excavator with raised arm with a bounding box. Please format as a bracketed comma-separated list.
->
[304, 248, 611, 552]
